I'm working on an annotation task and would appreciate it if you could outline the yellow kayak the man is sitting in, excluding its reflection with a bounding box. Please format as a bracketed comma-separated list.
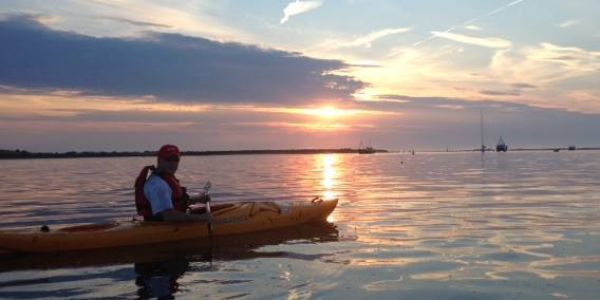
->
[0, 198, 338, 252]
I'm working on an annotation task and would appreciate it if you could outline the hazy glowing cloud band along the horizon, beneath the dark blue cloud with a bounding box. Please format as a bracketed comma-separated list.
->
[0, 89, 600, 151]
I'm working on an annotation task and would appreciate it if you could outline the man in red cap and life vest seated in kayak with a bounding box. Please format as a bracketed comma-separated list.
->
[135, 145, 210, 222]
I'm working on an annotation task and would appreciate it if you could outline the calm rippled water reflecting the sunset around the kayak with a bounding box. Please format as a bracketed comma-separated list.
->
[0, 151, 600, 299]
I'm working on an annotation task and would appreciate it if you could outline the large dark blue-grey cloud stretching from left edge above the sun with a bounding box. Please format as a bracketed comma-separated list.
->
[0, 16, 365, 103]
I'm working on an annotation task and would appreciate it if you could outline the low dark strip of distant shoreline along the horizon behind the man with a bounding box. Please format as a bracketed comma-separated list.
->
[0, 148, 388, 159]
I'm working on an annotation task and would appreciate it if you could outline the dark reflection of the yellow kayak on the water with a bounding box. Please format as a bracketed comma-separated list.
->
[0, 222, 339, 272]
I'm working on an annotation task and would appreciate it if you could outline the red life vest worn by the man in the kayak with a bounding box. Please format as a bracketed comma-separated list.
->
[135, 166, 189, 220]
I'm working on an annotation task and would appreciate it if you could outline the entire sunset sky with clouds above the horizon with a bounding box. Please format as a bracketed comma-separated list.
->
[0, 0, 600, 152]
